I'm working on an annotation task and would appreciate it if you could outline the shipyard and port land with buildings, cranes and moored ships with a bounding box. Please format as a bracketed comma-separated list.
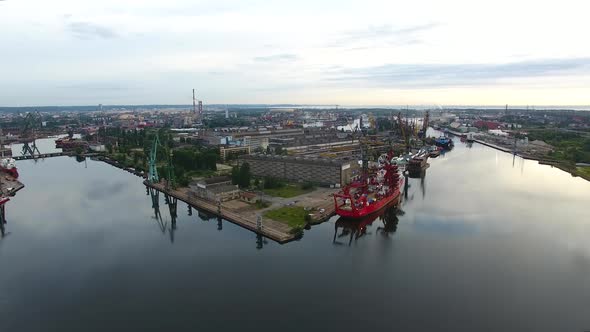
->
[2, 101, 588, 243]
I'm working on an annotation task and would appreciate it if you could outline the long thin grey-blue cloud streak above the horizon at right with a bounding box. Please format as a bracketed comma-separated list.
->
[325, 58, 590, 88]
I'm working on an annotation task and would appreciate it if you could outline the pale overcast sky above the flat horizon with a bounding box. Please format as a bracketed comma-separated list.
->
[0, 0, 590, 106]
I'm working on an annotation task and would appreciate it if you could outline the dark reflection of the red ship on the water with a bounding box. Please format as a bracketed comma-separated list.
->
[332, 207, 404, 246]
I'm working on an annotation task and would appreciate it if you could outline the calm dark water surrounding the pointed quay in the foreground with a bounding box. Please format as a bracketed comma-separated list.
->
[0, 136, 590, 331]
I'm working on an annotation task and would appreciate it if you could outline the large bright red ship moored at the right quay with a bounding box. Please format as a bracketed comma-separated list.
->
[334, 152, 404, 219]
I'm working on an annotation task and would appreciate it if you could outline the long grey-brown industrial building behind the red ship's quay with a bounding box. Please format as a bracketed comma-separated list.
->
[239, 154, 358, 187]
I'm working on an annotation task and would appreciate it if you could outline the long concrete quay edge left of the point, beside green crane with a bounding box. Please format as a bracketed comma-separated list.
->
[143, 180, 298, 244]
